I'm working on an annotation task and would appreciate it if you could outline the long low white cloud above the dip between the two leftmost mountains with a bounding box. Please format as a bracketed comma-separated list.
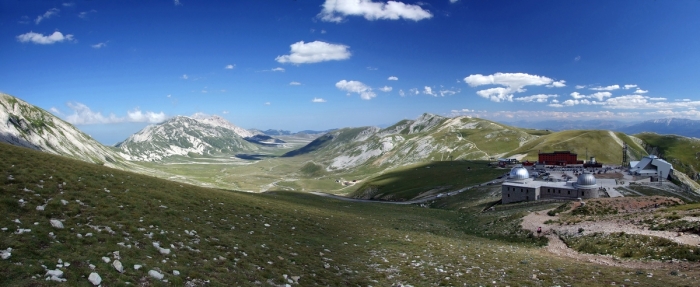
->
[62, 102, 166, 125]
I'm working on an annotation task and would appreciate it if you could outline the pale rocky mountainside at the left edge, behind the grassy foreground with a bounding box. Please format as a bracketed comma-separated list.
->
[0, 94, 126, 168]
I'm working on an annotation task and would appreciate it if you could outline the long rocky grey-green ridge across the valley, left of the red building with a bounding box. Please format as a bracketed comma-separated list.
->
[286, 114, 538, 171]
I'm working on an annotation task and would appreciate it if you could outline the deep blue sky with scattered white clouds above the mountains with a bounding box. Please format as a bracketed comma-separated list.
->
[0, 0, 700, 144]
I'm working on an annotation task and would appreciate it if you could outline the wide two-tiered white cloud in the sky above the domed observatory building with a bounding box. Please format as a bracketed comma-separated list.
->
[464, 73, 564, 102]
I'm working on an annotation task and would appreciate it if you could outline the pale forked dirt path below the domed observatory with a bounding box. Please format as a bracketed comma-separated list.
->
[521, 210, 700, 271]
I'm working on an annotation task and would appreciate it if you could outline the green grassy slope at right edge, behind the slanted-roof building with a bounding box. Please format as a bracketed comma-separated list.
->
[635, 133, 700, 180]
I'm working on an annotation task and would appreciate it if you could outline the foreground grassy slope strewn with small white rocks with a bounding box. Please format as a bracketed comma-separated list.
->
[0, 144, 693, 286]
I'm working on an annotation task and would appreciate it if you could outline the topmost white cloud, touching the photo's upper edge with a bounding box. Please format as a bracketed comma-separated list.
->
[318, 0, 433, 23]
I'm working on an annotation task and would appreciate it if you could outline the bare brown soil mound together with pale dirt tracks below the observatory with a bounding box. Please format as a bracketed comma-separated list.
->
[521, 196, 700, 274]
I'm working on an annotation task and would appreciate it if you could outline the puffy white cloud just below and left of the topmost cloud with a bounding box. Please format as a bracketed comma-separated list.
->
[275, 41, 350, 64]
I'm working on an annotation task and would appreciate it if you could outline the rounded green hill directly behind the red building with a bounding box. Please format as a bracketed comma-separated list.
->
[507, 130, 646, 164]
